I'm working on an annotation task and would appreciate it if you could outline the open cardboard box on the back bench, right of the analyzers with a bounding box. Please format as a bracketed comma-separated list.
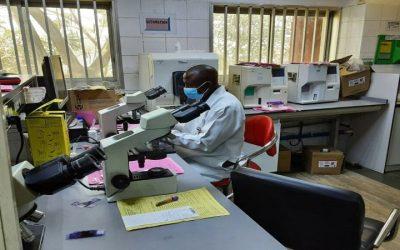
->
[340, 66, 371, 98]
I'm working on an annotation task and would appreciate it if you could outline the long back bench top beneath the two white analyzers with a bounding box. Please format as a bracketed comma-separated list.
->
[245, 97, 387, 120]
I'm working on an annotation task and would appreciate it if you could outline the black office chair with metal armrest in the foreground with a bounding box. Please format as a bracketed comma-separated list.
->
[231, 168, 399, 250]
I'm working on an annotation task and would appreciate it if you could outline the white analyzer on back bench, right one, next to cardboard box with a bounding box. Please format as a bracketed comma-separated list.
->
[285, 63, 340, 104]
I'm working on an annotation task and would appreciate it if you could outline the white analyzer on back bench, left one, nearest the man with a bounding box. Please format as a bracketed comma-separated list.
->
[227, 63, 288, 108]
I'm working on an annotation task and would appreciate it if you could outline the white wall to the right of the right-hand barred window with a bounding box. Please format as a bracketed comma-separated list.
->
[338, 0, 400, 60]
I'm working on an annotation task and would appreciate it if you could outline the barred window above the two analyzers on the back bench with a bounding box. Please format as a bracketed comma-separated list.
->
[212, 5, 340, 80]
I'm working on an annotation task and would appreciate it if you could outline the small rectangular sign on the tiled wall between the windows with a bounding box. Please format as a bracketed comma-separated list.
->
[140, 13, 176, 34]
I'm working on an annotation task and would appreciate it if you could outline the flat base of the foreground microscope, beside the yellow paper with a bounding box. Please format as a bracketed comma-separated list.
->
[107, 175, 178, 202]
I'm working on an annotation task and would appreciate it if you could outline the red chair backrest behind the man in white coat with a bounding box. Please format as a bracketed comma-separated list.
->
[244, 115, 276, 156]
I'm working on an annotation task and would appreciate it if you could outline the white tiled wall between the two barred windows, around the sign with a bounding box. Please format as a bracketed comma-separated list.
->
[115, 0, 347, 90]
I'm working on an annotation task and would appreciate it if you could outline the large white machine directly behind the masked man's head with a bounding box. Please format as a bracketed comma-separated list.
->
[139, 51, 218, 110]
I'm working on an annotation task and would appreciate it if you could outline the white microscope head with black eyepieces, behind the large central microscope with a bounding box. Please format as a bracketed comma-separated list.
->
[98, 87, 167, 138]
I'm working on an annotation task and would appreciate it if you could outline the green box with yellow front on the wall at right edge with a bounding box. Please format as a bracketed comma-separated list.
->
[374, 35, 400, 64]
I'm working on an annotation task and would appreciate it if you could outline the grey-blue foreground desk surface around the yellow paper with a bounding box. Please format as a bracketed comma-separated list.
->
[37, 154, 285, 250]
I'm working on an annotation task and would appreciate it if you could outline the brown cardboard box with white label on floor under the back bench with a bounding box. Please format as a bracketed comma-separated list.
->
[304, 146, 344, 174]
